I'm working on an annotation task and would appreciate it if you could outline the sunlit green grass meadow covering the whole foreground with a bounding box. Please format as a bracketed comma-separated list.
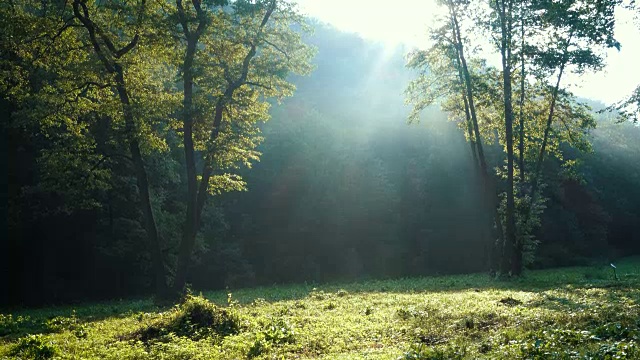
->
[0, 258, 640, 359]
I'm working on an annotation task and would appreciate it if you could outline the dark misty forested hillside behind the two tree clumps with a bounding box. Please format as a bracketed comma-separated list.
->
[2, 19, 640, 305]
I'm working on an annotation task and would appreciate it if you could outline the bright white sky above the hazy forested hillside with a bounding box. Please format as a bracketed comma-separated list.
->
[298, 0, 640, 103]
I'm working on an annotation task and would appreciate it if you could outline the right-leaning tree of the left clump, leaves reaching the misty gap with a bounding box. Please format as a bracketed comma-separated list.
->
[173, 0, 312, 292]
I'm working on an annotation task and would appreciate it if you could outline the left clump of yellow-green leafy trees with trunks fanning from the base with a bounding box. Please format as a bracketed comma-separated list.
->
[3, 0, 312, 296]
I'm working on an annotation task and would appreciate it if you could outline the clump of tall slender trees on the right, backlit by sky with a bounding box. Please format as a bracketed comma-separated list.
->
[408, 0, 618, 275]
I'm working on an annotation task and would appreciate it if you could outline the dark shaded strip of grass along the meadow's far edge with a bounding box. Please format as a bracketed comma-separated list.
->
[0, 257, 640, 342]
